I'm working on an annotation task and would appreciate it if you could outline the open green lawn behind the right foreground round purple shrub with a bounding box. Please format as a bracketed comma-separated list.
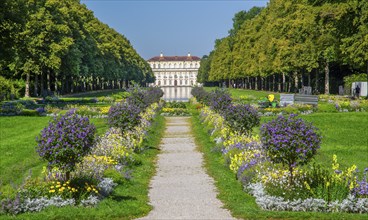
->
[261, 112, 368, 171]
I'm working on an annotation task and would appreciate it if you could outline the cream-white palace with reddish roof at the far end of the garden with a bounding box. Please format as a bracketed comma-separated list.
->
[147, 53, 201, 87]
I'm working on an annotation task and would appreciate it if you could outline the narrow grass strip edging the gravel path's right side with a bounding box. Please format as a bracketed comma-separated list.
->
[192, 112, 368, 219]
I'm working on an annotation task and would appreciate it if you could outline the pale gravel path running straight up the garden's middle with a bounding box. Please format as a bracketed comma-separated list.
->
[142, 117, 233, 219]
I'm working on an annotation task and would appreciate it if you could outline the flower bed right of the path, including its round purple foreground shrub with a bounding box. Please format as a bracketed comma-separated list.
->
[196, 87, 368, 213]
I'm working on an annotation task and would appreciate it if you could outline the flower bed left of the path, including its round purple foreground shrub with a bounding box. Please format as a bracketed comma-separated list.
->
[0, 86, 161, 214]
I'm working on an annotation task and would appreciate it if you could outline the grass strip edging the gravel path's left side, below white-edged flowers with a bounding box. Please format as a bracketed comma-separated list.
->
[0, 116, 165, 219]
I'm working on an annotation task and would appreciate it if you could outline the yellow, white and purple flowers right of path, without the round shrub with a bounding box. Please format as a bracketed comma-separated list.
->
[201, 107, 368, 213]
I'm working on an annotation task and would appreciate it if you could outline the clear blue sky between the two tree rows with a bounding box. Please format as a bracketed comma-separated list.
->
[81, 0, 268, 60]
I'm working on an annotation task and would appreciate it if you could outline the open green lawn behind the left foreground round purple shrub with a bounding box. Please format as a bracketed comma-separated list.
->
[0, 116, 107, 195]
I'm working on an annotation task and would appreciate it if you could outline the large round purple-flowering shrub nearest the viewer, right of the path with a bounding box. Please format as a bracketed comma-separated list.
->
[261, 115, 321, 184]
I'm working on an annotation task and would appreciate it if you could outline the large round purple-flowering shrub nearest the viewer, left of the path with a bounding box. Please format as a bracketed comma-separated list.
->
[36, 110, 96, 179]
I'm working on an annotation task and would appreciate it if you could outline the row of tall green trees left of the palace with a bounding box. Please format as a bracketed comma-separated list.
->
[0, 0, 154, 96]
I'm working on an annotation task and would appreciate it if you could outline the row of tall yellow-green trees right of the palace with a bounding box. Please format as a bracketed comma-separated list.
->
[198, 0, 368, 94]
